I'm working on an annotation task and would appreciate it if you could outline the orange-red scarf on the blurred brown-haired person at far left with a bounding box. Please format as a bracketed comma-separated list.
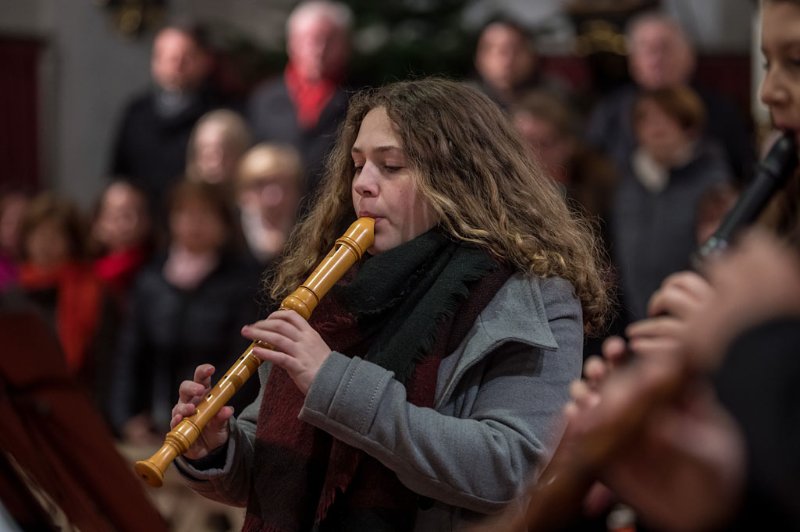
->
[19, 262, 103, 373]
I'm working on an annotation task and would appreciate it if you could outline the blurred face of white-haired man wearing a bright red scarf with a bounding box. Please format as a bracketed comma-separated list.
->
[286, 13, 350, 82]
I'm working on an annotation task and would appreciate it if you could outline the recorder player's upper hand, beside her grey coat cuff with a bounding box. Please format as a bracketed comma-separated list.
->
[242, 310, 331, 395]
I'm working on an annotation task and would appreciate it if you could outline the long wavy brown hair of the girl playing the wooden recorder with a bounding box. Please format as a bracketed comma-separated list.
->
[271, 78, 609, 331]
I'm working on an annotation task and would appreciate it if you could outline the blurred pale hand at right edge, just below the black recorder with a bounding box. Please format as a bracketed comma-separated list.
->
[627, 230, 800, 371]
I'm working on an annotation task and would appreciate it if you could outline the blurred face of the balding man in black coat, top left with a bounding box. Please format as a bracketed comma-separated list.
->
[150, 28, 211, 92]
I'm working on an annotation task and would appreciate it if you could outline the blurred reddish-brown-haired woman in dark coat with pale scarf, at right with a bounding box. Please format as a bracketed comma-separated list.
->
[610, 86, 730, 321]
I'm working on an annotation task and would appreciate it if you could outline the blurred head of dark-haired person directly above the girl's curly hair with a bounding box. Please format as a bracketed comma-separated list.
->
[474, 17, 568, 109]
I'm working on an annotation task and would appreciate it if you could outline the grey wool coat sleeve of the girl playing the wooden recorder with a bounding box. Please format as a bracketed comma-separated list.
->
[300, 276, 583, 513]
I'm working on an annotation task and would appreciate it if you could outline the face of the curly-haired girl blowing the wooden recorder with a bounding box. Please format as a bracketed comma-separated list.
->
[351, 107, 437, 253]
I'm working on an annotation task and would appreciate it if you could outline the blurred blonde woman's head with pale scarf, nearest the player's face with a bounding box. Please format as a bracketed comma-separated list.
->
[236, 143, 303, 265]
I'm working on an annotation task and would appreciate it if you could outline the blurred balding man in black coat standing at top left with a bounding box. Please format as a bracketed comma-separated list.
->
[110, 22, 223, 214]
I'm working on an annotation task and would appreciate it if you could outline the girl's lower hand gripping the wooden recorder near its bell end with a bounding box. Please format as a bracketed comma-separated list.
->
[169, 364, 233, 460]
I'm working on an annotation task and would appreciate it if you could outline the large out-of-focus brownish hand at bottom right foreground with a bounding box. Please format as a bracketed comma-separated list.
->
[540, 357, 745, 530]
